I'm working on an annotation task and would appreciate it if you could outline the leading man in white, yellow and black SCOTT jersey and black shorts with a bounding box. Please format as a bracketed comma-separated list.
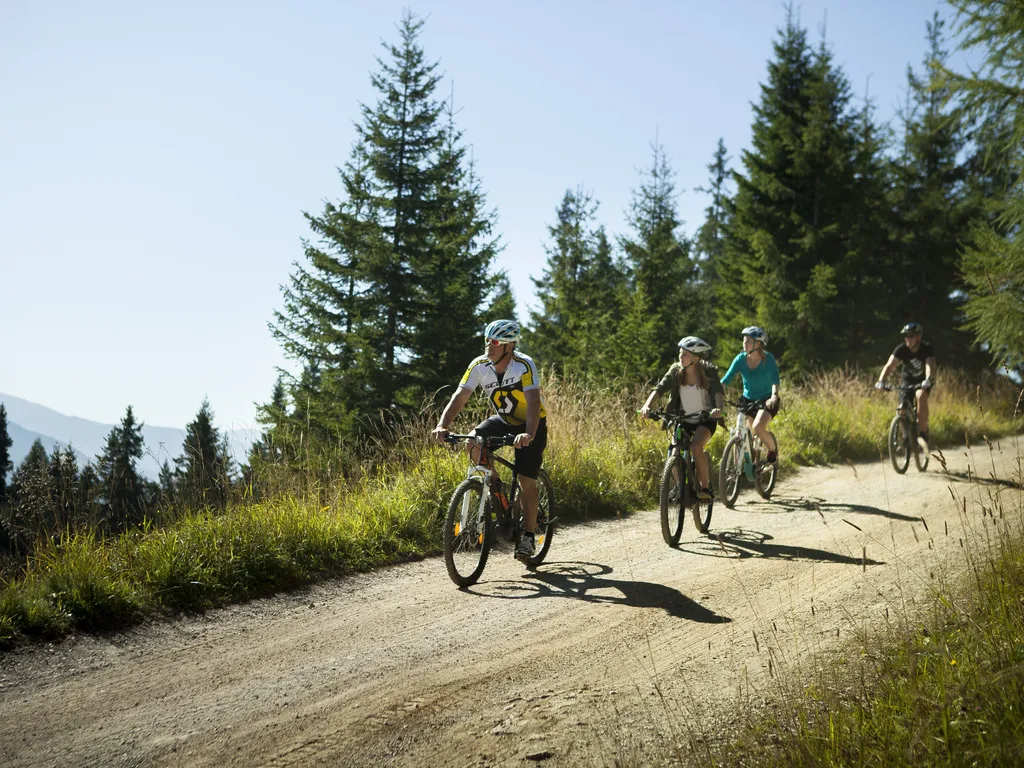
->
[433, 319, 548, 562]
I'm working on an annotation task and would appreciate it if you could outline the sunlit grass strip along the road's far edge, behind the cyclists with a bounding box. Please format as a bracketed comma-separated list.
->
[0, 373, 1020, 643]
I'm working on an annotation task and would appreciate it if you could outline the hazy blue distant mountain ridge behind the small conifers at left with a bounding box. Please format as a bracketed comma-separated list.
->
[0, 392, 254, 480]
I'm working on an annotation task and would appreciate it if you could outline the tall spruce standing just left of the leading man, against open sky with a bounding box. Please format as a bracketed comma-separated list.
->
[271, 12, 497, 444]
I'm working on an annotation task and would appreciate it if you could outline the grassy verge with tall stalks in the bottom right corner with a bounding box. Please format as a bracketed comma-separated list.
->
[697, 436, 1024, 768]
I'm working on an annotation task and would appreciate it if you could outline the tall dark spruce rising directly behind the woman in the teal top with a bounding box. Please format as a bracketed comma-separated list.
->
[717, 6, 866, 371]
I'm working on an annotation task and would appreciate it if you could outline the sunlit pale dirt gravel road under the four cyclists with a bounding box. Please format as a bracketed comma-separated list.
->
[0, 440, 1021, 768]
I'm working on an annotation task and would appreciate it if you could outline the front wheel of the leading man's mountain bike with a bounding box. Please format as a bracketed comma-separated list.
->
[444, 477, 494, 587]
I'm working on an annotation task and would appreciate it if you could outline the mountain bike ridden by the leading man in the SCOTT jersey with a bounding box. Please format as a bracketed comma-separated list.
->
[443, 434, 555, 587]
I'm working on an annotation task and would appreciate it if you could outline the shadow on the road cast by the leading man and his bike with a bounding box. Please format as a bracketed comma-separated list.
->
[467, 562, 732, 624]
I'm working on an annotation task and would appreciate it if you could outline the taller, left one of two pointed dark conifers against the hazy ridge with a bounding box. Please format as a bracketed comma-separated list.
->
[96, 406, 146, 532]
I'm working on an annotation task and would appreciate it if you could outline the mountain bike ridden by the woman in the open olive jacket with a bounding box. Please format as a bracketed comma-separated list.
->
[647, 411, 715, 547]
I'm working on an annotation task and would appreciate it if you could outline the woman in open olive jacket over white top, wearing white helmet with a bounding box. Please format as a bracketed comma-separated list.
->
[640, 336, 725, 502]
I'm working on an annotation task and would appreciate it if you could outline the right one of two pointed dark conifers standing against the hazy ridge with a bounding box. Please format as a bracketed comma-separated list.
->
[174, 399, 230, 509]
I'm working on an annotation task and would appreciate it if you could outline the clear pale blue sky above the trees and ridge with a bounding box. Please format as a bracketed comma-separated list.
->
[0, 0, 963, 436]
